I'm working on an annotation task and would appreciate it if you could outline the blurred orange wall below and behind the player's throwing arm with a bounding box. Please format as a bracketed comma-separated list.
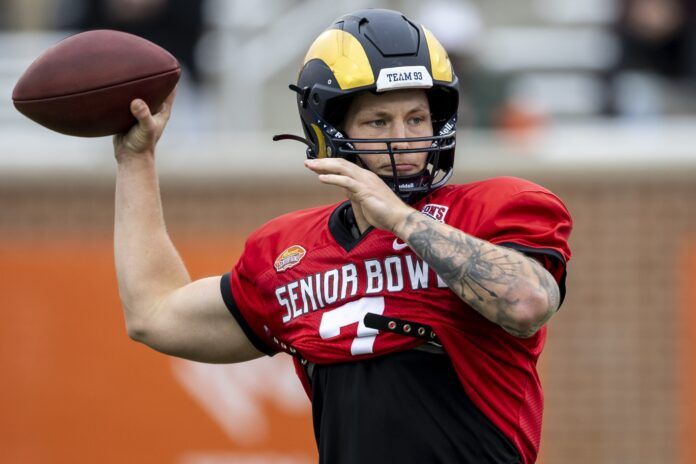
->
[0, 237, 316, 463]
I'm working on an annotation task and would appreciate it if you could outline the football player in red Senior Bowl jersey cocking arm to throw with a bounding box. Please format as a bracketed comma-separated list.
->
[114, 10, 571, 464]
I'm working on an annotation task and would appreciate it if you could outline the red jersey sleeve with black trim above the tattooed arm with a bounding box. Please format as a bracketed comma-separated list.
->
[477, 191, 573, 301]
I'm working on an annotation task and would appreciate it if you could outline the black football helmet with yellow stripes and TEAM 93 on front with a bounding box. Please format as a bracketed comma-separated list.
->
[273, 9, 459, 203]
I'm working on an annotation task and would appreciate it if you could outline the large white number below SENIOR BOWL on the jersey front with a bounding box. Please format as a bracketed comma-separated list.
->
[319, 296, 384, 356]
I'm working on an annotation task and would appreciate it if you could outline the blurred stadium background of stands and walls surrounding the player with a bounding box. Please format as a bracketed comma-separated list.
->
[0, 0, 696, 464]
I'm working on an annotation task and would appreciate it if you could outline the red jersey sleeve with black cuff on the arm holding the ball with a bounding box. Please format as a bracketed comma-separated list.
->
[220, 243, 278, 356]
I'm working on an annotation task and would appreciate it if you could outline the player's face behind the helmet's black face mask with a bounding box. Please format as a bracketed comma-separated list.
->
[343, 89, 433, 176]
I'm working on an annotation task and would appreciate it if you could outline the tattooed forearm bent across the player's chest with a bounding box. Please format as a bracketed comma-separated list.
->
[404, 213, 560, 337]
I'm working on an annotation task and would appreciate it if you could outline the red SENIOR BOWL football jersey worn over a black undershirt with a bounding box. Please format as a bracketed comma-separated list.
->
[229, 177, 572, 463]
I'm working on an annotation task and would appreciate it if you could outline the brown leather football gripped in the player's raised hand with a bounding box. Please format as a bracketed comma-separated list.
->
[12, 30, 181, 137]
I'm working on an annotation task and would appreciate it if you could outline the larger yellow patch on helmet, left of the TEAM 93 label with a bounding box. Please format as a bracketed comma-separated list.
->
[303, 29, 372, 90]
